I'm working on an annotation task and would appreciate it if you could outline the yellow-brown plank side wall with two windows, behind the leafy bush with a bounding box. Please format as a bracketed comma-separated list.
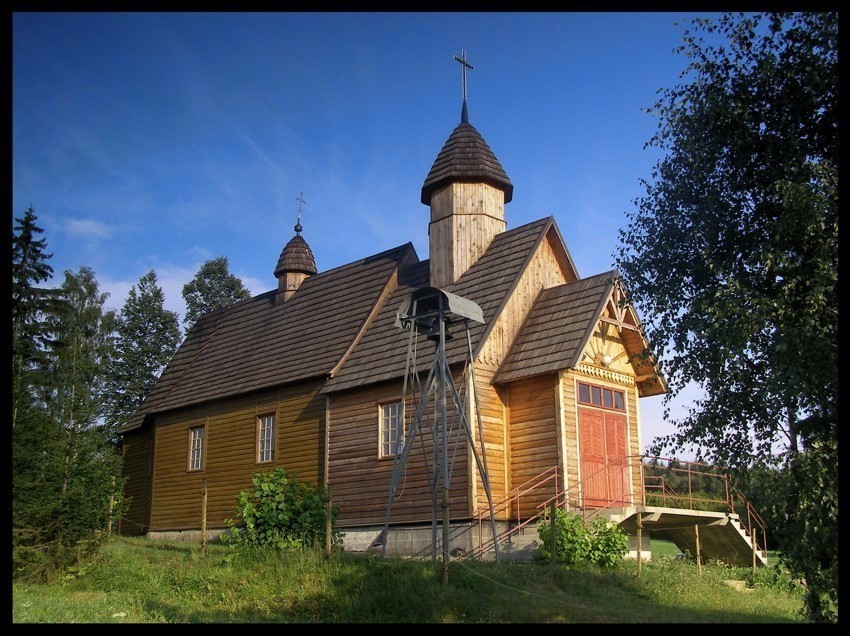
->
[151, 383, 325, 531]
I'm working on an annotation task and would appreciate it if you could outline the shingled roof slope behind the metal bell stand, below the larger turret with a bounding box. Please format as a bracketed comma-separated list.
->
[323, 217, 554, 393]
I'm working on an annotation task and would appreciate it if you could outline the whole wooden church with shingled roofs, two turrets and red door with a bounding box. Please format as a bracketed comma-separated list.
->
[120, 63, 680, 553]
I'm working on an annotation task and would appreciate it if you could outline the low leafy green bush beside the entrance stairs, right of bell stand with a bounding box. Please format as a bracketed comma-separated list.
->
[537, 508, 629, 567]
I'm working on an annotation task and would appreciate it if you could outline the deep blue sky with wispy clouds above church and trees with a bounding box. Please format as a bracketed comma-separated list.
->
[12, 12, 711, 442]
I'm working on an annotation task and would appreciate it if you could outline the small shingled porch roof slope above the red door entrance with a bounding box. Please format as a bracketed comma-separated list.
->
[493, 270, 617, 382]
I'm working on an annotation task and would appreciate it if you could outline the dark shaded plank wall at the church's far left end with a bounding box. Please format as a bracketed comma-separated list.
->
[118, 426, 153, 536]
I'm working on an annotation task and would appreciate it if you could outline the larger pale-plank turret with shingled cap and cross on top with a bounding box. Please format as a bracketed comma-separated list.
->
[421, 51, 514, 288]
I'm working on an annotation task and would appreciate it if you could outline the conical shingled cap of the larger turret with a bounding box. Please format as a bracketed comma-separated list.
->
[422, 122, 514, 205]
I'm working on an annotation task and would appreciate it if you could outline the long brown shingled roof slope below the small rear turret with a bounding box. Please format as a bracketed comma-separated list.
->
[123, 243, 418, 431]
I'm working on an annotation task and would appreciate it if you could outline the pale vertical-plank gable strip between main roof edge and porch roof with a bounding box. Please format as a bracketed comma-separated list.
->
[478, 230, 567, 366]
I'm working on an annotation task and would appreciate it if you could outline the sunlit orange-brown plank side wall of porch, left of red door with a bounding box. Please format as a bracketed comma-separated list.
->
[508, 374, 559, 518]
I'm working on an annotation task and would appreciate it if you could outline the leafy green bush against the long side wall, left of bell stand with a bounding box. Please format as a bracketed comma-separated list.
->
[221, 468, 342, 549]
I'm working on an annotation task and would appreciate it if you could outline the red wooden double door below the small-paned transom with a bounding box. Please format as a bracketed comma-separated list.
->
[578, 407, 629, 508]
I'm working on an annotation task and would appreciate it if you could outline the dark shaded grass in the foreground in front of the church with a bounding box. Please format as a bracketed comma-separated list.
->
[136, 555, 800, 624]
